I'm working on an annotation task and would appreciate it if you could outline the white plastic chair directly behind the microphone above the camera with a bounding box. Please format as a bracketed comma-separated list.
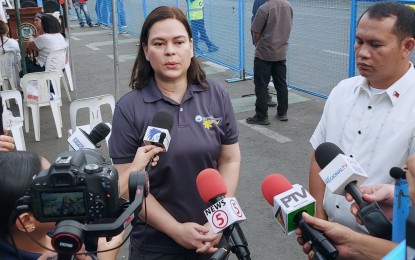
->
[68, 94, 115, 149]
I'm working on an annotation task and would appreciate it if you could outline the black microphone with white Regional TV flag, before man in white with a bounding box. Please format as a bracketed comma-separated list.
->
[315, 142, 392, 240]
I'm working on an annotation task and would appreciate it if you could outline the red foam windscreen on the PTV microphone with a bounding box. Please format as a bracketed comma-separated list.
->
[261, 173, 293, 206]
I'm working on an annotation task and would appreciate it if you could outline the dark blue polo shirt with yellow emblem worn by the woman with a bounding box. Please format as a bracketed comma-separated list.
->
[109, 79, 238, 253]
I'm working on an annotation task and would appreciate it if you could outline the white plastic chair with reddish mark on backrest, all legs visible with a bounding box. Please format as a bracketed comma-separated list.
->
[20, 71, 62, 141]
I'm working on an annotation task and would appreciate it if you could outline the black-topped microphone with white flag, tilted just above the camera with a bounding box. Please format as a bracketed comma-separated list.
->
[68, 122, 111, 151]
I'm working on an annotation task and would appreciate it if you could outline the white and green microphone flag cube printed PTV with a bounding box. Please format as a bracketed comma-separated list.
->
[273, 184, 316, 235]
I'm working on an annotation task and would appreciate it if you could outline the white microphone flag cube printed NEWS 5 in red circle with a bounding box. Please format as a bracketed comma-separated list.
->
[204, 197, 246, 233]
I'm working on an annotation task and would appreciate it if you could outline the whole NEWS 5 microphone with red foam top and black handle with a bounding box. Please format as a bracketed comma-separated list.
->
[196, 169, 251, 260]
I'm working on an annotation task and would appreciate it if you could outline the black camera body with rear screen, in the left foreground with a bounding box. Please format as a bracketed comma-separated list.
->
[30, 150, 119, 223]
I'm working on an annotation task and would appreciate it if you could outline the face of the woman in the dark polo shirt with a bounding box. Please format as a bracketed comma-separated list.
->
[143, 19, 193, 81]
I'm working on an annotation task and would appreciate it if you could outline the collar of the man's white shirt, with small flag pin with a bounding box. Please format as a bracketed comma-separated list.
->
[353, 62, 415, 106]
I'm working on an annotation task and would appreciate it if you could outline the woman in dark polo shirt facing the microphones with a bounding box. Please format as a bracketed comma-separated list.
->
[109, 6, 240, 260]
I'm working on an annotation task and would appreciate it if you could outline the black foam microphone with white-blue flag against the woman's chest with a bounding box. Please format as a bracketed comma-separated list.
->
[144, 111, 174, 152]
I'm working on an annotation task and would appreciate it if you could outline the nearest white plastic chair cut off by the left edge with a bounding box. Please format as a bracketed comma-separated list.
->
[0, 90, 26, 151]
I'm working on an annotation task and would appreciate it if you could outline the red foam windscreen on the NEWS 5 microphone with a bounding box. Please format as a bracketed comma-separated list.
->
[196, 168, 227, 203]
